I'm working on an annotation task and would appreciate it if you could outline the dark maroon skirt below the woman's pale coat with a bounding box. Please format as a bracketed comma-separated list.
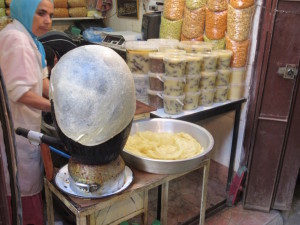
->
[7, 192, 44, 225]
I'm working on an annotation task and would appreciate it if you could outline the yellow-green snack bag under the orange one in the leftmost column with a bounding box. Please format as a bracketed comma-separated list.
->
[159, 16, 182, 40]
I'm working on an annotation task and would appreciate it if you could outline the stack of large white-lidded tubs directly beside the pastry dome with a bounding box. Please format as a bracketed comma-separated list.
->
[125, 41, 157, 104]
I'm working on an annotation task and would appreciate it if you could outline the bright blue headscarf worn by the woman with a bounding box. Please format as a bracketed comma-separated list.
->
[10, 0, 46, 68]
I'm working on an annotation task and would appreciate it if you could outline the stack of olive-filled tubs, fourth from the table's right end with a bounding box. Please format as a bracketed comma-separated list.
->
[183, 53, 202, 110]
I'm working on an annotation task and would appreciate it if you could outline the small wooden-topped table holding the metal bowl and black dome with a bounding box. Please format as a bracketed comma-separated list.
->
[44, 157, 210, 225]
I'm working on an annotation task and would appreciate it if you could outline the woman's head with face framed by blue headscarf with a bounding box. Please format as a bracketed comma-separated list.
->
[10, 0, 54, 36]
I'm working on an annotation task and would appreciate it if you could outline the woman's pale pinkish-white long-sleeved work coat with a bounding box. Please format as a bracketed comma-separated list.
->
[0, 20, 47, 196]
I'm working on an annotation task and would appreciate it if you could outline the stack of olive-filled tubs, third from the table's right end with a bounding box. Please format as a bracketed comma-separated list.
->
[198, 52, 218, 106]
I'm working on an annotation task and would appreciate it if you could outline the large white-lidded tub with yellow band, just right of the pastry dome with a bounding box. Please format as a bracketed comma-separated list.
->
[125, 41, 157, 74]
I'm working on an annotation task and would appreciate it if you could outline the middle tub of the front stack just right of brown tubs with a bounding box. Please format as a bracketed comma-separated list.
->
[163, 76, 185, 96]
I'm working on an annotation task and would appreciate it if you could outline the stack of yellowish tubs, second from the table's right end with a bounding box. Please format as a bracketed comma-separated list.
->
[213, 50, 232, 102]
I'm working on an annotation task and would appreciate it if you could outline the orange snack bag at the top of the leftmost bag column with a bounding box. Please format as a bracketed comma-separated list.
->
[163, 0, 184, 20]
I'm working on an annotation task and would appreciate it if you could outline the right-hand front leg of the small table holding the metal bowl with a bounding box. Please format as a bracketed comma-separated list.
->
[199, 159, 210, 225]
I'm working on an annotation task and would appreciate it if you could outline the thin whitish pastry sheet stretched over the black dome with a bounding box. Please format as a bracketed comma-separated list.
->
[50, 45, 136, 146]
